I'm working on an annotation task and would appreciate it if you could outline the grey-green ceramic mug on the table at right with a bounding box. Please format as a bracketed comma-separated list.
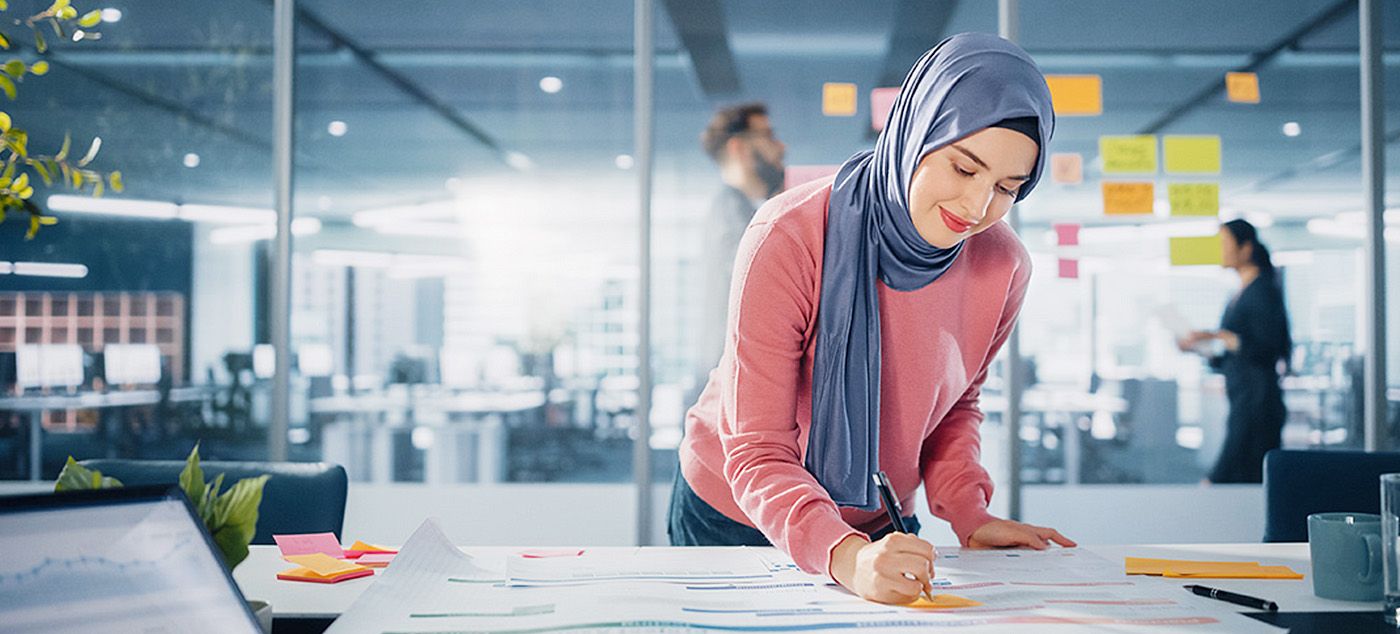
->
[1308, 512, 1380, 600]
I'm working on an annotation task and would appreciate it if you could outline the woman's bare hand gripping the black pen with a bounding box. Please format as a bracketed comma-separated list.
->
[832, 533, 938, 605]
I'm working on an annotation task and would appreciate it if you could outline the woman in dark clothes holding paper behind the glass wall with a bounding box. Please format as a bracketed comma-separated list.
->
[1177, 220, 1294, 484]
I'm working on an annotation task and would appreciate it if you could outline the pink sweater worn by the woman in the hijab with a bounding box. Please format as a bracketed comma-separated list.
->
[680, 179, 1030, 575]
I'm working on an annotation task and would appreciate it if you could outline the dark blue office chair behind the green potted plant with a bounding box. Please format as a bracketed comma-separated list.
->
[81, 459, 347, 544]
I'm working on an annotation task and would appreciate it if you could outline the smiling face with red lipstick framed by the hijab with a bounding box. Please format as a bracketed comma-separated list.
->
[909, 127, 1039, 249]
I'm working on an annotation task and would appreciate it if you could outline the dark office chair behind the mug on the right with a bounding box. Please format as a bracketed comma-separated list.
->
[1264, 449, 1400, 542]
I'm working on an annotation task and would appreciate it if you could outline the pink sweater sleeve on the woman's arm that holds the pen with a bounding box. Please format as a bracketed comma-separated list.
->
[718, 224, 864, 577]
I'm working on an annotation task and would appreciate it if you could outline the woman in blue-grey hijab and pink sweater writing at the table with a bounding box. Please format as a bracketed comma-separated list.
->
[669, 34, 1074, 603]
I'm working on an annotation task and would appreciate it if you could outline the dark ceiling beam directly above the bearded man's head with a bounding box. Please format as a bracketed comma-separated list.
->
[665, 0, 739, 101]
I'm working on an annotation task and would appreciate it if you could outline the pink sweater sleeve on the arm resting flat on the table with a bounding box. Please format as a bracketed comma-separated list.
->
[920, 257, 1030, 546]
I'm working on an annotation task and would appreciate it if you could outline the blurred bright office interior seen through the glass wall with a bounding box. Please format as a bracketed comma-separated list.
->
[0, 0, 1400, 543]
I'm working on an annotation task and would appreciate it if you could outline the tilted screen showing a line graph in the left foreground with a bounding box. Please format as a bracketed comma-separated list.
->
[0, 487, 260, 634]
